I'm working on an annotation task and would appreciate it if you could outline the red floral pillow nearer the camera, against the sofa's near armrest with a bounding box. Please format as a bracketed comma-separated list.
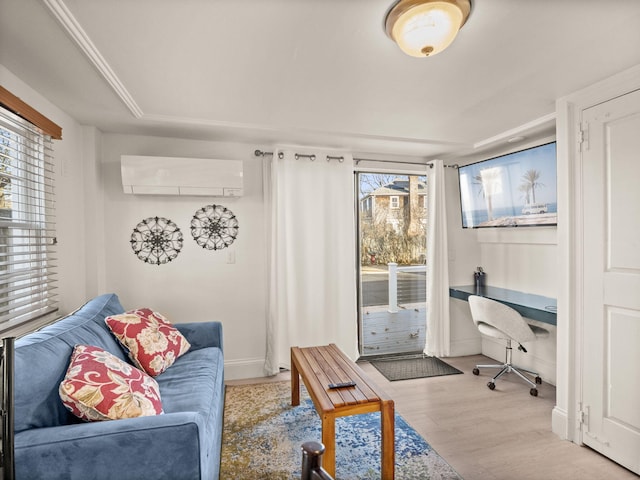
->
[58, 345, 162, 421]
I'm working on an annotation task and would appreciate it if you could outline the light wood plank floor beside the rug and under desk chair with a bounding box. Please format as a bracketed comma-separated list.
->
[227, 355, 640, 480]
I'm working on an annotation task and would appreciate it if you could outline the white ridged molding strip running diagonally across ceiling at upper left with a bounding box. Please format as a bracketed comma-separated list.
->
[43, 0, 144, 118]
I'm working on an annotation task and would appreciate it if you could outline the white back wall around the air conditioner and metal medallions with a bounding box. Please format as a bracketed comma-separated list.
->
[97, 134, 267, 379]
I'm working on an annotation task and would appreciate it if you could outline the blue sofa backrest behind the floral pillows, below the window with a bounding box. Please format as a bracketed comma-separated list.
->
[14, 294, 126, 432]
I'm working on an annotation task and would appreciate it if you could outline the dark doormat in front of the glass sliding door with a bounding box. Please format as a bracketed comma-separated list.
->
[370, 355, 462, 382]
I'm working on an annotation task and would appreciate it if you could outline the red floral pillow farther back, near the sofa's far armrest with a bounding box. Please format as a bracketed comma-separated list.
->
[105, 308, 191, 377]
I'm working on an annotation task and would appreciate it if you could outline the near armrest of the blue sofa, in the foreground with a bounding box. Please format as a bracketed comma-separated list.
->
[15, 412, 217, 480]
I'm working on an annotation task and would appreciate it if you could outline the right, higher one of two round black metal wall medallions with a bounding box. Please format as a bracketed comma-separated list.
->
[191, 205, 238, 250]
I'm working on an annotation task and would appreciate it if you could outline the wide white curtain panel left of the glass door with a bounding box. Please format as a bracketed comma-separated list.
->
[265, 149, 358, 375]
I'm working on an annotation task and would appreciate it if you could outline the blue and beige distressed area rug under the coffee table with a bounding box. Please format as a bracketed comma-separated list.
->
[220, 382, 461, 480]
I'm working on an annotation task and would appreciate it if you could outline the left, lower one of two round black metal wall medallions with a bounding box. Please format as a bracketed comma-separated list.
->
[131, 217, 183, 265]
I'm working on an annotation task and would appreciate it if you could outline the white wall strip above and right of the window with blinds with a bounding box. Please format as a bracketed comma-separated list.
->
[0, 65, 88, 326]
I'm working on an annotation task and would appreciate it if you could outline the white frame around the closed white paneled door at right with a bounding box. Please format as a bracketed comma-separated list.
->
[552, 65, 640, 445]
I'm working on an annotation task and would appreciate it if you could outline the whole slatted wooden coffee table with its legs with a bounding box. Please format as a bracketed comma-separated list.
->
[291, 343, 395, 480]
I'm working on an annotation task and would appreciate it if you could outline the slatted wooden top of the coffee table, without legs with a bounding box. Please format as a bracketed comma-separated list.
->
[291, 344, 390, 413]
